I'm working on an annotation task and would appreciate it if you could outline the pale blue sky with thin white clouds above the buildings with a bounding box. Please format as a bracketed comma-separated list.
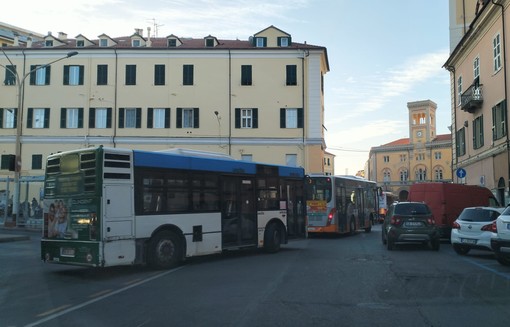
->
[0, 0, 451, 174]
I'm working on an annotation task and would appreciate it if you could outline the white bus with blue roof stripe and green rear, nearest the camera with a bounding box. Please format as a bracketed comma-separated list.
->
[41, 146, 306, 268]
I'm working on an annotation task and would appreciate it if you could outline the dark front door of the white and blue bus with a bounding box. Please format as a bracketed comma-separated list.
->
[285, 181, 306, 237]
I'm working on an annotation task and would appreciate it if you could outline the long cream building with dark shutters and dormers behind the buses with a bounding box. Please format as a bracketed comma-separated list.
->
[0, 26, 331, 200]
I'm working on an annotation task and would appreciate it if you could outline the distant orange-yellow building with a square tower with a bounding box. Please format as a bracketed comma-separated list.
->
[365, 100, 452, 199]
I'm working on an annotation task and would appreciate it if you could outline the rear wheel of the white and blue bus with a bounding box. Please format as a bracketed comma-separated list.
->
[147, 231, 182, 269]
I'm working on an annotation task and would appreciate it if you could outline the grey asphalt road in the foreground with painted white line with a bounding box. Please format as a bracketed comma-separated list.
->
[0, 226, 510, 327]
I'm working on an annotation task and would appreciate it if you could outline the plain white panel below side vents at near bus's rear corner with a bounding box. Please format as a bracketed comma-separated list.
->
[102, 184, 135, 266]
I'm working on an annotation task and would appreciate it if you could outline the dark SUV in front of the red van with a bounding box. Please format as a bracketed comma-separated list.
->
[382, 202, 441, 251]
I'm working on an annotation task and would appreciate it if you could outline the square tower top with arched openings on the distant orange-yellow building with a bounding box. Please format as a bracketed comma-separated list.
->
[407, 100, 437, 144]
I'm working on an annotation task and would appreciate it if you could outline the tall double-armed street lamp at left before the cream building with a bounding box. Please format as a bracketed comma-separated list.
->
[0, 47, 78, 225]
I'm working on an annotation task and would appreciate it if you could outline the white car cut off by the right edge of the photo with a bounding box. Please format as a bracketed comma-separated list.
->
[491, 206, 510, 266]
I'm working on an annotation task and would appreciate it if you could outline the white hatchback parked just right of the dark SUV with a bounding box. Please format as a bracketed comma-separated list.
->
[450, 207, 504, 255]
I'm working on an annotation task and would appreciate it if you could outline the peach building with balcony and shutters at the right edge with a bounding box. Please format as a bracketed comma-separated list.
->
[444, 0, 510, 204]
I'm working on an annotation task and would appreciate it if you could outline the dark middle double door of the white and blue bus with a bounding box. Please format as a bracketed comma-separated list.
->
[221, 176, 258, 247]
